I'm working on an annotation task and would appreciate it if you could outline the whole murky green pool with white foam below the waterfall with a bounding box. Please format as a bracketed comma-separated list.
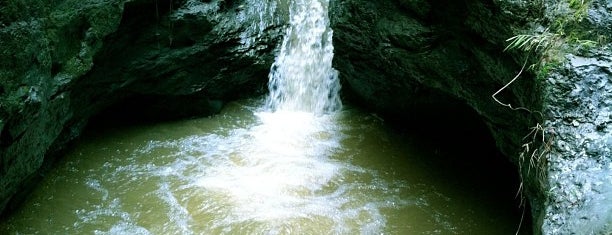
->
[0, 100, 520, 234]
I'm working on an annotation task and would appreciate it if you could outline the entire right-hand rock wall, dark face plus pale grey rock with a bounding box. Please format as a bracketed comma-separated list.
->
[330, 0, 612, 234]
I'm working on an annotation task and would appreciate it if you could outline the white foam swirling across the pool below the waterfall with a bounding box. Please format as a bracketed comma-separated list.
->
[57, 107, 415, 234]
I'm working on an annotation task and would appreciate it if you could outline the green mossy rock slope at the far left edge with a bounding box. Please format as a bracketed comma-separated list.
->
[0, 1, 121, 217]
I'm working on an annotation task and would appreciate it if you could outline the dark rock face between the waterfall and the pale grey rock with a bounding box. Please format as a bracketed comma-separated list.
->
[330, 0, 544, 231]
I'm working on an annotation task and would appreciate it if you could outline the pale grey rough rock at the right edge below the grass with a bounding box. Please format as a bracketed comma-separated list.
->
[542, 50, 612, 234]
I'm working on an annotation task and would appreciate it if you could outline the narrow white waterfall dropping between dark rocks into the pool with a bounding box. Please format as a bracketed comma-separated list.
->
[267, 0, 342, 114]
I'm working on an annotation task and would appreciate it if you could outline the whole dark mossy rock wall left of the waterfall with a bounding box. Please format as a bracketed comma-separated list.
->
[0, 0, 287, 217]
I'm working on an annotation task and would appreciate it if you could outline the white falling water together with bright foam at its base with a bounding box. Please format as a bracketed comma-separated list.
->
[190, 0, 401, 231]
